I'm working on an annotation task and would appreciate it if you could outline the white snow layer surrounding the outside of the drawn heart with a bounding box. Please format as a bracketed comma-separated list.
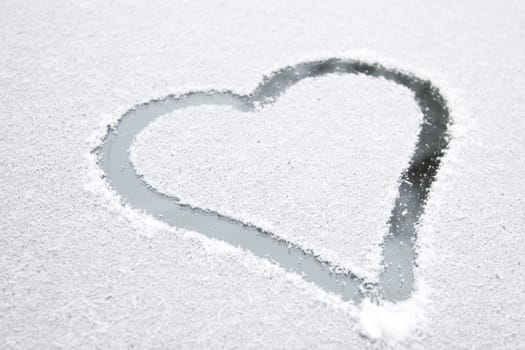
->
[0, 0, 525, 349]
